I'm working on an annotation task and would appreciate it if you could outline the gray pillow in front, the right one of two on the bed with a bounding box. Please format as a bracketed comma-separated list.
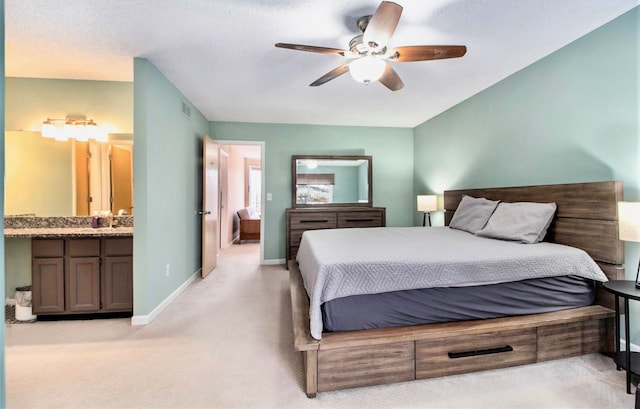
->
[478, 202, 557, 244]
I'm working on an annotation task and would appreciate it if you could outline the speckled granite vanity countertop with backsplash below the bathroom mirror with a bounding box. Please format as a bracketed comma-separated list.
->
[4, 215, 133, 238]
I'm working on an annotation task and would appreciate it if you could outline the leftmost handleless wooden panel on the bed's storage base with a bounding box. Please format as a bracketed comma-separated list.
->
[318, 342, 415, 392]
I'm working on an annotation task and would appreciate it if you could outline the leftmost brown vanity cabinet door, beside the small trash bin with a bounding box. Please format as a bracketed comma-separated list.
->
[31, 257, 64, 315]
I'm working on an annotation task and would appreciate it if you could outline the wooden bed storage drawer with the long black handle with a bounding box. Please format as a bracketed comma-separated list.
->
[416, 328, 537, 379]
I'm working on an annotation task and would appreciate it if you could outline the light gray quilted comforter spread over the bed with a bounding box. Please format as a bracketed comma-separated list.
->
[297, 227, 607, 339]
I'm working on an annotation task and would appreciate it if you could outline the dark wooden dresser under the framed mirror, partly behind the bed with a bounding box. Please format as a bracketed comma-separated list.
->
[286, 206, 386, 263]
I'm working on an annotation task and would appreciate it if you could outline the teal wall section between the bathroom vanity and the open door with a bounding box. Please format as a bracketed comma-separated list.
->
[133, 58, 209, 316]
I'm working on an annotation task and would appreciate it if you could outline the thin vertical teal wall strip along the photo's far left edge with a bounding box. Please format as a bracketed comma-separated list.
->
[0, 0, 6, 408]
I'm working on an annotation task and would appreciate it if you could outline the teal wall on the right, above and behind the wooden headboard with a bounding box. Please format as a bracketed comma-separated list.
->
[414, 7, 640, 334]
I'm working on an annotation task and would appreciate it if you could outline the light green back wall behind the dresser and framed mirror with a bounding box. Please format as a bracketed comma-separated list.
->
[209, 122, 415, 260]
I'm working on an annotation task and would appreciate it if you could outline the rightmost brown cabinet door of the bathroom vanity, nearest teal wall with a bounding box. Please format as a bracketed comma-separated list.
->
[102, 256, 133, 311]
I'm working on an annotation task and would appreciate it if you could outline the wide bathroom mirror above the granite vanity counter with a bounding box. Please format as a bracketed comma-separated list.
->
[5, 131, 133, 216]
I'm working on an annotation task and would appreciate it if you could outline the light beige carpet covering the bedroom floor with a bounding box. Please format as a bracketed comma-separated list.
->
[6, 244, 634, 409]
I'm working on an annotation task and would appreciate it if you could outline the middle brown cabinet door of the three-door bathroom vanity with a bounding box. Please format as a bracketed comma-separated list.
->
[66, 257, 100, 313]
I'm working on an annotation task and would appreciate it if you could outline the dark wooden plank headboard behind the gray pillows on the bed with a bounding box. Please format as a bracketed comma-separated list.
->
[444, 181, 624, 308]
